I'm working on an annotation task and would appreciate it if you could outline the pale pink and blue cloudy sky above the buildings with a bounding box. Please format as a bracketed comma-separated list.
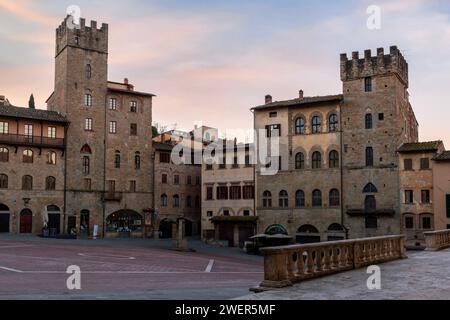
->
[0, 0, 450, 148]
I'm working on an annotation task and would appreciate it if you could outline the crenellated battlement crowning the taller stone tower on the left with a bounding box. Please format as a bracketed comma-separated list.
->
[56, 16, 108, 55]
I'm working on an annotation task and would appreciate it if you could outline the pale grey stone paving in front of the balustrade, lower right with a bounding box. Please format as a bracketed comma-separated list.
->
[241, 249, 450, 300]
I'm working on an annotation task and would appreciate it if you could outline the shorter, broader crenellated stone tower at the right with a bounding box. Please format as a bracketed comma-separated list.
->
[341, 46, 418, 238]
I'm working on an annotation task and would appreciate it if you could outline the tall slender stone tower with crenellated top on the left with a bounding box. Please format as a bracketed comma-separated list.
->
[48, 18, 108, 231]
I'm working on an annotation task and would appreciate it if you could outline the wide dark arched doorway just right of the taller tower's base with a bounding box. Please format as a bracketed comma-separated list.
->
[106, 210, 143, 234]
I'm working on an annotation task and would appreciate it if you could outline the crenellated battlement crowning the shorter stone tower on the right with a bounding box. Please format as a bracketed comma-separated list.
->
[341, 46, 409, 87]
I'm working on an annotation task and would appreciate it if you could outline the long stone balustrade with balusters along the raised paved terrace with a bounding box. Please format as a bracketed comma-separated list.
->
[261, 236, 406, 288]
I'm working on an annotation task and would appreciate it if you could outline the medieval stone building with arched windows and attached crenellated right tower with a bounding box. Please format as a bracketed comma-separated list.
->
[253, 47, 418, 242]
